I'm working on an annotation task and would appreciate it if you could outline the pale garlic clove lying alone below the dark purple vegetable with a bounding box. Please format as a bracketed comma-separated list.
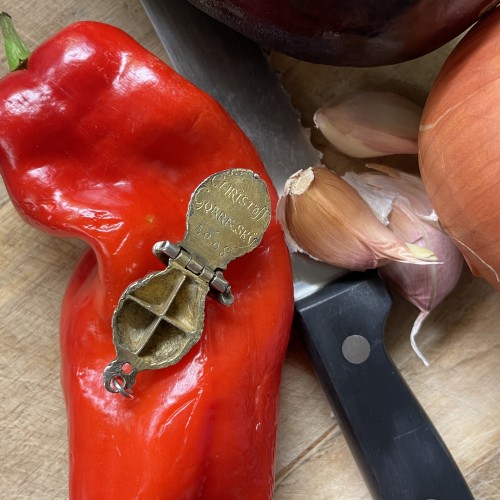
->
[314, 92, 422, 158]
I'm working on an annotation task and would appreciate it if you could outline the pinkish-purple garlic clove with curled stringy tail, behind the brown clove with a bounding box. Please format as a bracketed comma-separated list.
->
[344, 165, 463, 366]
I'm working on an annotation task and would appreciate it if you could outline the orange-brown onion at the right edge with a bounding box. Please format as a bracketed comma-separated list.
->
[419, 8, 500, 291]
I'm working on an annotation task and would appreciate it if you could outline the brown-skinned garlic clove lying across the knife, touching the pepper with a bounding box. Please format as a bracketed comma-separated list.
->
[278, 167, 437, 270]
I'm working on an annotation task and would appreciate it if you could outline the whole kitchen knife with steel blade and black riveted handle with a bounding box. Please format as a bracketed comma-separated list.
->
[141, 0, 473, 500]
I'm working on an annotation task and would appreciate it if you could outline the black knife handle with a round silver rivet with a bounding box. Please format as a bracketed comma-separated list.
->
[296, 273, 473, 500]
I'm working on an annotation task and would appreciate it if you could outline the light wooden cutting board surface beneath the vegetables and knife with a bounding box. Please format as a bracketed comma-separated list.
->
[0, 0, 500, 500]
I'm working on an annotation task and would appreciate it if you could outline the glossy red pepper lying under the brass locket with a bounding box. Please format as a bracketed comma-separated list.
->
[0, 22, 293, 500]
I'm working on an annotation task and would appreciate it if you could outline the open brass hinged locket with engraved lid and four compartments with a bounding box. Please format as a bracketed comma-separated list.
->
[104, 169, 271, 397]
